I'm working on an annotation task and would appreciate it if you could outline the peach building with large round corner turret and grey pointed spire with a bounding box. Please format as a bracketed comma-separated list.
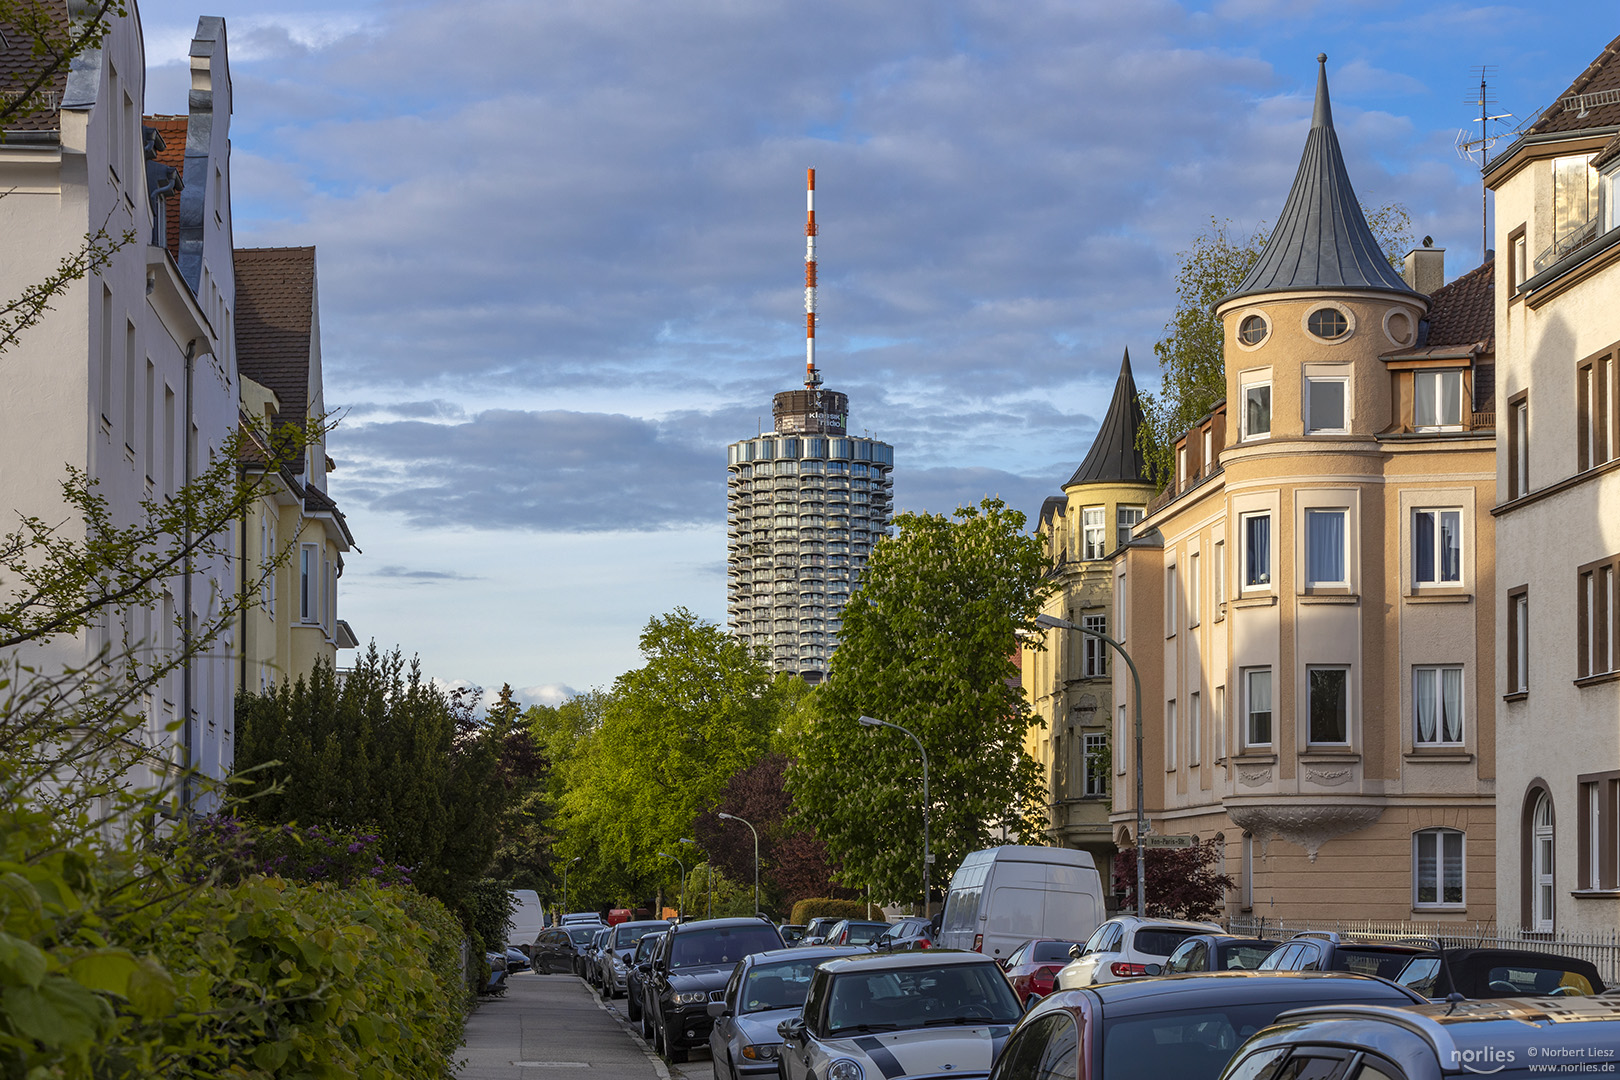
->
[1113, 57, 1497, 921]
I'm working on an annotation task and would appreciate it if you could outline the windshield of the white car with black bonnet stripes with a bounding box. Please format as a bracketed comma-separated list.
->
[826, 963, 1021, 1035]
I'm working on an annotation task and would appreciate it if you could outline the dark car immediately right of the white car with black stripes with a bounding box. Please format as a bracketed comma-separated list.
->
[990, 972, 1418, 1080]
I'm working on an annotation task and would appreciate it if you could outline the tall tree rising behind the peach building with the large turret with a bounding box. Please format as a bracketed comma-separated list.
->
[1137, 202, 1411, 487]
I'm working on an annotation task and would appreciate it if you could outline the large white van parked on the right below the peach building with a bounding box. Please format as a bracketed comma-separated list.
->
[940, 845, 1103, 960]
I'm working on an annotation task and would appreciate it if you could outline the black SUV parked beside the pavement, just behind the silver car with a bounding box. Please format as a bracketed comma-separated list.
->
[642, 918, 782, 1064]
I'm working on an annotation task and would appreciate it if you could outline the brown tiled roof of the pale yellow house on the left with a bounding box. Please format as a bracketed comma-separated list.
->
[235, 248, 314, 473]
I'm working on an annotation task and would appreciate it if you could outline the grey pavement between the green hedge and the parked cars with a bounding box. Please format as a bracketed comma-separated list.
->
[455, 972, 711, 1080]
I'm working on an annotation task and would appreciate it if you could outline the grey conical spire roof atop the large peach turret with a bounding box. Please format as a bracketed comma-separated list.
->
[1221, 53, 1418, 303]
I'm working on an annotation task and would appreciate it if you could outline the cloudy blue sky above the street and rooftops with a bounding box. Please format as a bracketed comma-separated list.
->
[139, 0, 1620, 703]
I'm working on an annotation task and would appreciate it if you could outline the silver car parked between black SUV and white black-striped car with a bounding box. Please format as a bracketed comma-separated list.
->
[708, 946, 867, 1080]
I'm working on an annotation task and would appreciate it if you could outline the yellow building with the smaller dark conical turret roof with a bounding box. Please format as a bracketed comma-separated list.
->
[1021, 351, 1155, 891]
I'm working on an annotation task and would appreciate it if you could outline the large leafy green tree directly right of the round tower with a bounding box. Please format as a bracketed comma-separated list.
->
[787, 499, 1051, 900]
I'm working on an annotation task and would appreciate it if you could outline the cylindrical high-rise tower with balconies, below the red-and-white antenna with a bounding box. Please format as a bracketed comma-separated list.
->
[726, 389, 894, 683]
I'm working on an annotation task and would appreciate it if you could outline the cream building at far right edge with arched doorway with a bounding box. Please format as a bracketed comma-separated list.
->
[1486, 37, 1620, 934]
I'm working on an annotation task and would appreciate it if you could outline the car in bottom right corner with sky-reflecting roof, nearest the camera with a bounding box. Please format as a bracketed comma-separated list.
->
[1223, 997, 1620, 1080]
